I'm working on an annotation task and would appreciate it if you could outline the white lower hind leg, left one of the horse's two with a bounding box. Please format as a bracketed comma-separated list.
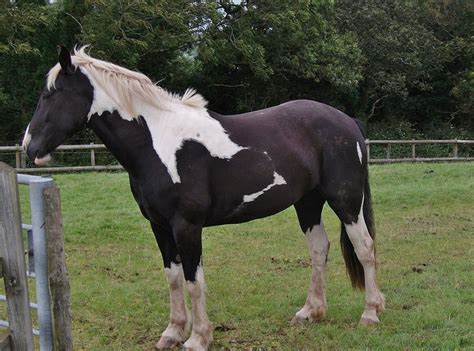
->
[292, 222, 329, 324]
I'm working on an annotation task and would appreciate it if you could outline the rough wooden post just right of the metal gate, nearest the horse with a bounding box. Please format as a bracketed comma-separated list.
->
[43, 186, 72, 351]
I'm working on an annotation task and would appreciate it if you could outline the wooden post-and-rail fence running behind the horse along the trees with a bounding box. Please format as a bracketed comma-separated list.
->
[0, 140, 474, 173]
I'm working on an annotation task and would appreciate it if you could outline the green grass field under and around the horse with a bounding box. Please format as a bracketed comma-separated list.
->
[6, 163, 474, 350]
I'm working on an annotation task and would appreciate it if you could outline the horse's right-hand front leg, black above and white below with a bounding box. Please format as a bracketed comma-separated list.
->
[172, 218, 212, 351]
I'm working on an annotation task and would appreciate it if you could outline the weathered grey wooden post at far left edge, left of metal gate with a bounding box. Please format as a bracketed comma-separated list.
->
[0, 162, 33, 351]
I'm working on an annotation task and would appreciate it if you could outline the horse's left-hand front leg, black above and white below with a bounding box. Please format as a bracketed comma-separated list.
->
[151, 223, 188, 349]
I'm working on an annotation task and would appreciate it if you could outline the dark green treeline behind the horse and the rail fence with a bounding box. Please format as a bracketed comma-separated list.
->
[0, 0, 474, 143]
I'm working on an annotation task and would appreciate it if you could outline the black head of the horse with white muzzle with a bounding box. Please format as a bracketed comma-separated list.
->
[23, 47, 94, 165]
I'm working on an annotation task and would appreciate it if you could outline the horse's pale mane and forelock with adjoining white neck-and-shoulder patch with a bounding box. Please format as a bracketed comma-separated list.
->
[57, 49, 245, 183]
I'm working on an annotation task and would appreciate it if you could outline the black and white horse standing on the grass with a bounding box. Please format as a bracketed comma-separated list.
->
[23, 47, 384, 350]
